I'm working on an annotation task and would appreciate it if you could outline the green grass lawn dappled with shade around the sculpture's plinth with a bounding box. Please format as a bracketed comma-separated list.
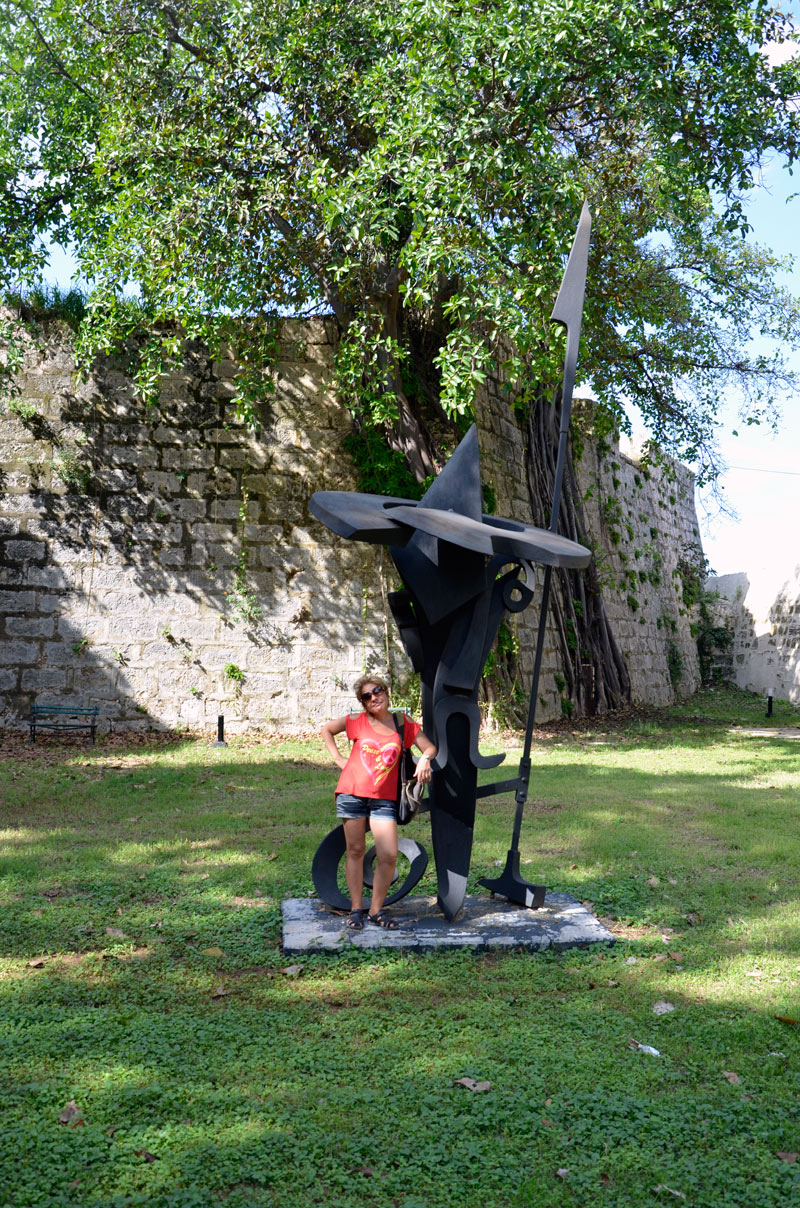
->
[0, 692, 800, 1208]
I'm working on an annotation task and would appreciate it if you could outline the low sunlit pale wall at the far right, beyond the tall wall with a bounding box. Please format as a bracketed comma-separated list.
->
[707, 565, 800, 704]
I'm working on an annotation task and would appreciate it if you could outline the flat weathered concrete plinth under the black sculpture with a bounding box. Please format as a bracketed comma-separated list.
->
[282, 893, 614, 954]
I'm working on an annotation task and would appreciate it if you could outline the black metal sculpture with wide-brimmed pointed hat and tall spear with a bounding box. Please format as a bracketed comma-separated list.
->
[309, 207, 591, 919]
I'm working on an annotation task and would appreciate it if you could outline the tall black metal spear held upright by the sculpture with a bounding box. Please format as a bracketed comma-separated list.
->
[479, 202, 592, 910]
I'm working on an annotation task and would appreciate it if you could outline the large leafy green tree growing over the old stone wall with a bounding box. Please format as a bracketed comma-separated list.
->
[0, 0, 800, 705]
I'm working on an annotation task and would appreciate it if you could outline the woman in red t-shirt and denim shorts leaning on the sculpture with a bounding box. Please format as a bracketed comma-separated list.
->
[320, 675, 436, 931]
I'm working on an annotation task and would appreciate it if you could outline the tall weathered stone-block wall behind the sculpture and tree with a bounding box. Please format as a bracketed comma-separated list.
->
[0, 320, 698, 731]
